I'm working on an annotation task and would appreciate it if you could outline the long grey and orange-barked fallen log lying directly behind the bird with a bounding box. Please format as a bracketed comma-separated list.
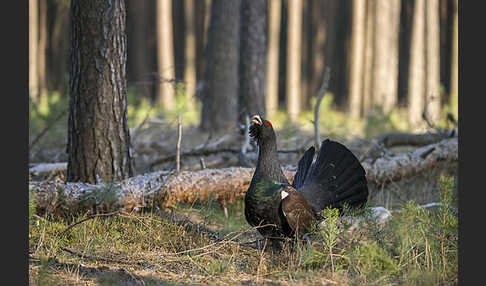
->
[29, 137, 458, 215]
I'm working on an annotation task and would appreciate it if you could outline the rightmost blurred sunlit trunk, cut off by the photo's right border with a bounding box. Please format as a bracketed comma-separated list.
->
[449, 0, 459, 117]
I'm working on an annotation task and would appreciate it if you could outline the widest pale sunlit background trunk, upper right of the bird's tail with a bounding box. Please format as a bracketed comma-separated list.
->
[372, 0, 400, 112]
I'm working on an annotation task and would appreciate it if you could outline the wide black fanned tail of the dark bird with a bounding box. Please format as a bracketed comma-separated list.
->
[296, 139, 368, 213]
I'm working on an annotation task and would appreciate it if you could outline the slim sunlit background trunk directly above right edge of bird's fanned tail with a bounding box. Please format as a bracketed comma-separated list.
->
[349, 0, 366, 119]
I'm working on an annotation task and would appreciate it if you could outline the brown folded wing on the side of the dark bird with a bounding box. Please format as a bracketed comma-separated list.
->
[282, 186, 315, 236]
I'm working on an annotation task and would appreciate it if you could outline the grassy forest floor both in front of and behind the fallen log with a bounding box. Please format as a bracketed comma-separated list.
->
[29, 93, 458, 285]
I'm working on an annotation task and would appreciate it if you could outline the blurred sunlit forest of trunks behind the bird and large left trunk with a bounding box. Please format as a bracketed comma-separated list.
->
[29, 0, 458, 172]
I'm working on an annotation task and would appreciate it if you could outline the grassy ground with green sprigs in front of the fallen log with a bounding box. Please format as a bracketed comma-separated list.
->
[29, 177, 458, 285]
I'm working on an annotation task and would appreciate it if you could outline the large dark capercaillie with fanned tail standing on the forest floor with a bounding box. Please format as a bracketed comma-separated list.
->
[245, 115, 368, 241]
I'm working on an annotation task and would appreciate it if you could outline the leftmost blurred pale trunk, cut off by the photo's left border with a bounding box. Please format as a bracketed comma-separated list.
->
[29, 0, 39, 100]
